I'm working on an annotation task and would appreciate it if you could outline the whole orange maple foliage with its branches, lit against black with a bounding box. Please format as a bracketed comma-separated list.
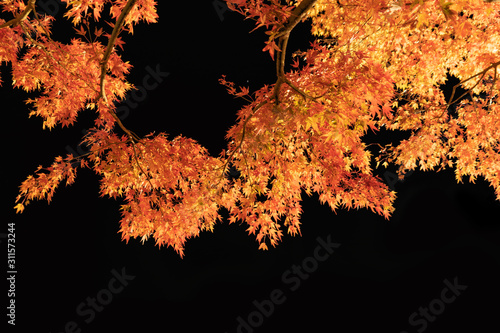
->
[5, 0, 500, 256]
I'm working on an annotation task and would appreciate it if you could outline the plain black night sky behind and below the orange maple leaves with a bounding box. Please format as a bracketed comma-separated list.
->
[0, 0, 500, 333]
